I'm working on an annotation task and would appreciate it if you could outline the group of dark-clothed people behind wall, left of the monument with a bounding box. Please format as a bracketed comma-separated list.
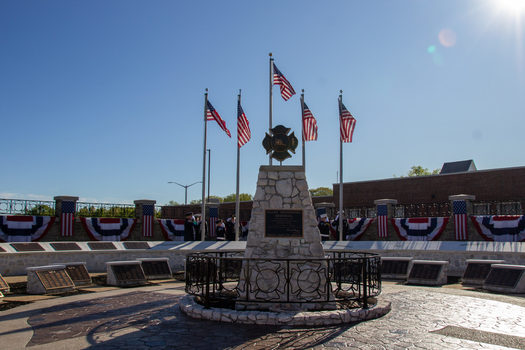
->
[184, 213, 248, 241]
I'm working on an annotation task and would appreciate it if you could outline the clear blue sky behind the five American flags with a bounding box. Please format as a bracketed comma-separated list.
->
[0, 0, 525, 204]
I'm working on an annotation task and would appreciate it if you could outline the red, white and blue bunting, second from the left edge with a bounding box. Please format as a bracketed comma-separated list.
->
[80, 218, 135, 241]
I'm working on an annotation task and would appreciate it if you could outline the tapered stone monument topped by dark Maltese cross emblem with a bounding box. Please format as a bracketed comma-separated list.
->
[236, 126, 335, 310]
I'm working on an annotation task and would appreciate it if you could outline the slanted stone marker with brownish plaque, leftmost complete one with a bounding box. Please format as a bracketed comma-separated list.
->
[26, 265, 75, 294]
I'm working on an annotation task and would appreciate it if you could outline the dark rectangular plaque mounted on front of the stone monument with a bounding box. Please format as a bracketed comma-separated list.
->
[264, 209, 303, 238]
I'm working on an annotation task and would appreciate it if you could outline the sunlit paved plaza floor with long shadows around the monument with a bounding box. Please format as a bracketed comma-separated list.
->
[0, 281, 525, 350]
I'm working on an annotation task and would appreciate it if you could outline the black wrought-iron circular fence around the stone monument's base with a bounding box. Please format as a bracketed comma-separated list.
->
[186, 252, 381, 308]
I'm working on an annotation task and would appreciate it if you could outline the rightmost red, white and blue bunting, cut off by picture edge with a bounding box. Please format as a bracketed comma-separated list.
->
[470, 215, 525, 242]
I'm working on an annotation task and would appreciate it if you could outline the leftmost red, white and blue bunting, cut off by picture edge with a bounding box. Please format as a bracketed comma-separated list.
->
[0, 215, 55, 242]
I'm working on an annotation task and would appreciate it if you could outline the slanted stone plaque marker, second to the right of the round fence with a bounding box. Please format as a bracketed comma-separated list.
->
[407, 260, 449, 286]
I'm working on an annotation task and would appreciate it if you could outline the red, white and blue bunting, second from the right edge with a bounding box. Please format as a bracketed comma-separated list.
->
[392, 217, 448, 241]
